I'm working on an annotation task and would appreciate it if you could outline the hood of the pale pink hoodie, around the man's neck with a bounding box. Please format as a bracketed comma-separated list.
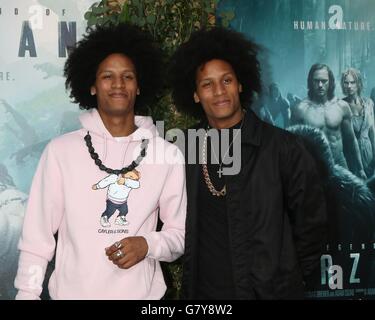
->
[79, 109, 159, 141]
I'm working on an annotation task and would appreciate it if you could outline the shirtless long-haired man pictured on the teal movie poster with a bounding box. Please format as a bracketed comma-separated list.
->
[291, 64, 367, 179]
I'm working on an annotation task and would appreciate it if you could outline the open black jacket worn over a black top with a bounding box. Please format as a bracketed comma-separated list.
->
[182, 111, 326, 299]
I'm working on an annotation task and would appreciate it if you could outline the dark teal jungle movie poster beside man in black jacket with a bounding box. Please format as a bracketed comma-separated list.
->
[220, 0, 375, 299]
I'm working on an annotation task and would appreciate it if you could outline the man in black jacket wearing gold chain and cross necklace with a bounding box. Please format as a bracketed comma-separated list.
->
[171, 28, 326, 299]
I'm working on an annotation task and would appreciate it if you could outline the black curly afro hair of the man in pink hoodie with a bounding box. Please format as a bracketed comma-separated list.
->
[64, 23, 163, 114]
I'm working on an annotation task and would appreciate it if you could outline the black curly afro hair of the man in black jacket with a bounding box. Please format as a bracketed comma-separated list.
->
[169, 27, 261, 119]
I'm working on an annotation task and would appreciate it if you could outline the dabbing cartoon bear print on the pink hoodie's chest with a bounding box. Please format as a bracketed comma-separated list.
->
[92, 169, 141, 228]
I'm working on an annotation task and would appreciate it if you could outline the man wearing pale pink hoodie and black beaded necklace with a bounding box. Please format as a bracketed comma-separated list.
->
[15, 24, 186, 299]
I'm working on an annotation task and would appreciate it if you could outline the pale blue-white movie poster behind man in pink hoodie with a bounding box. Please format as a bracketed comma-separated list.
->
[0, 0, 94, 299]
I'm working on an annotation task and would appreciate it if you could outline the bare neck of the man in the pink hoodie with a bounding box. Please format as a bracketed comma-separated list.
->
[98, 109, 136, 137]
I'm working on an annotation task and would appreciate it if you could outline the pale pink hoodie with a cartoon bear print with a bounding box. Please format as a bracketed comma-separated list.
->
[15, 109, 186, 299]
